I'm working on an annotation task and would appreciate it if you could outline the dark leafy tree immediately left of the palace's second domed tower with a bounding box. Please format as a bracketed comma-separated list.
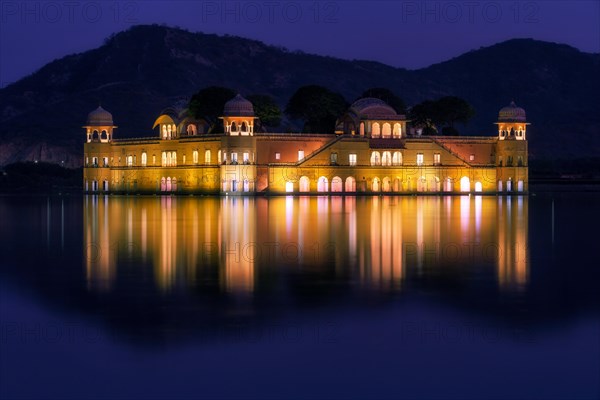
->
[188, 86, 236, 132]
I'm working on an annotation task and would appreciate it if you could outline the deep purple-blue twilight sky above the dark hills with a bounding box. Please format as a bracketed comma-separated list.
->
[0, 0, 600, 87]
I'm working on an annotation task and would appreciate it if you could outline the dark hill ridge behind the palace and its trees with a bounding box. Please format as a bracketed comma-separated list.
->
[0, 25, 600, 166]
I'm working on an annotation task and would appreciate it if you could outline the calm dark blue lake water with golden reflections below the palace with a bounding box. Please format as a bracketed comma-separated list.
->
[0, 192, 600, 398]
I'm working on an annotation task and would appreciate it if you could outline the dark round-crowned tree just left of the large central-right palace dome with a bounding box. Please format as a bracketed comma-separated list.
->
[285, 85, 348, 133]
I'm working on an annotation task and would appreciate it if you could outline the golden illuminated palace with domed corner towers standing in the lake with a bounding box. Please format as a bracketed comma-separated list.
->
[83, 95, 528, 195]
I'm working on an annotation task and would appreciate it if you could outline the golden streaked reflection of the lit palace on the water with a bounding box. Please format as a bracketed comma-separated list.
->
[84, 196, 528, 293]
